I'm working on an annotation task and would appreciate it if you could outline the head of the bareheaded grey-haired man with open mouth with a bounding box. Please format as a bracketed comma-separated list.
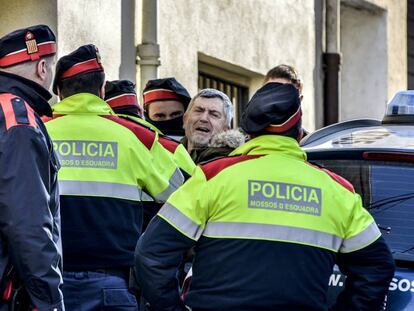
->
[184, 89, 233, 159]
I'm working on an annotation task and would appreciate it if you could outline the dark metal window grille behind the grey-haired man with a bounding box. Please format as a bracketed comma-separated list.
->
[198, 72, 249, 128]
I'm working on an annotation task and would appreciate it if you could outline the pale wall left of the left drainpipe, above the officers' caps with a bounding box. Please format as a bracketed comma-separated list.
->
[0, 0, 123, 79]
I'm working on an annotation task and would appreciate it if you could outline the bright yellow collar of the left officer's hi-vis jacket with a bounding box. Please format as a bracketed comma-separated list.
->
[52, 93, 114, 115]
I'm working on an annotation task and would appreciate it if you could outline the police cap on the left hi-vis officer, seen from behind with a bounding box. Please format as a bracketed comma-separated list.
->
[53, 44, 104, 94]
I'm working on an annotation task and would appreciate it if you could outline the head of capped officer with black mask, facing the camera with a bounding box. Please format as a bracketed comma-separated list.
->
[143, 78, 191, 138]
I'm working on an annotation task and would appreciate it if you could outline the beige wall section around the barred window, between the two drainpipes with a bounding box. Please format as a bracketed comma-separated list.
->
[158, 0, 315, 129]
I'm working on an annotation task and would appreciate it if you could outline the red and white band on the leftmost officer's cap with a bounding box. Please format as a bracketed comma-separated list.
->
[0, 41, 56, 67]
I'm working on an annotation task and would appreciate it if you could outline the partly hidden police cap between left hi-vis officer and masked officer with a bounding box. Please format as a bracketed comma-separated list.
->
[105, 80, 139, 108]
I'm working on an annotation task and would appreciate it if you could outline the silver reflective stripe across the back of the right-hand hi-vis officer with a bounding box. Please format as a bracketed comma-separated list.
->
[203, 222, 342, 252]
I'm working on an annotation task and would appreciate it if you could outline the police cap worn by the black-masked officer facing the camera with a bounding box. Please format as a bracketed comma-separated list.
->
[143, 78, 191, 108]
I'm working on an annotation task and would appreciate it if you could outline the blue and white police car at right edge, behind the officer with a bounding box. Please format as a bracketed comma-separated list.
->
[301, 91, 414, 311]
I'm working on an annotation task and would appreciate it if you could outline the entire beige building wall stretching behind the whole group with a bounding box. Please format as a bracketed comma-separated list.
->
[0, 0, 407, 130]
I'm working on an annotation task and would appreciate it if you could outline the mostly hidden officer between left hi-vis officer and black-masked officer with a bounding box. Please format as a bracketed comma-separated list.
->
[105, 80, 195, 176]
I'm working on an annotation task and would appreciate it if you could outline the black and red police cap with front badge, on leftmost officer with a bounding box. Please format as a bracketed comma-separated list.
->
[0, 25, 56, 68]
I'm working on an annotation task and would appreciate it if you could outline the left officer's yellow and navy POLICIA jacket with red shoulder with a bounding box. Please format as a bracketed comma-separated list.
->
[46, 93, 184, 271]
